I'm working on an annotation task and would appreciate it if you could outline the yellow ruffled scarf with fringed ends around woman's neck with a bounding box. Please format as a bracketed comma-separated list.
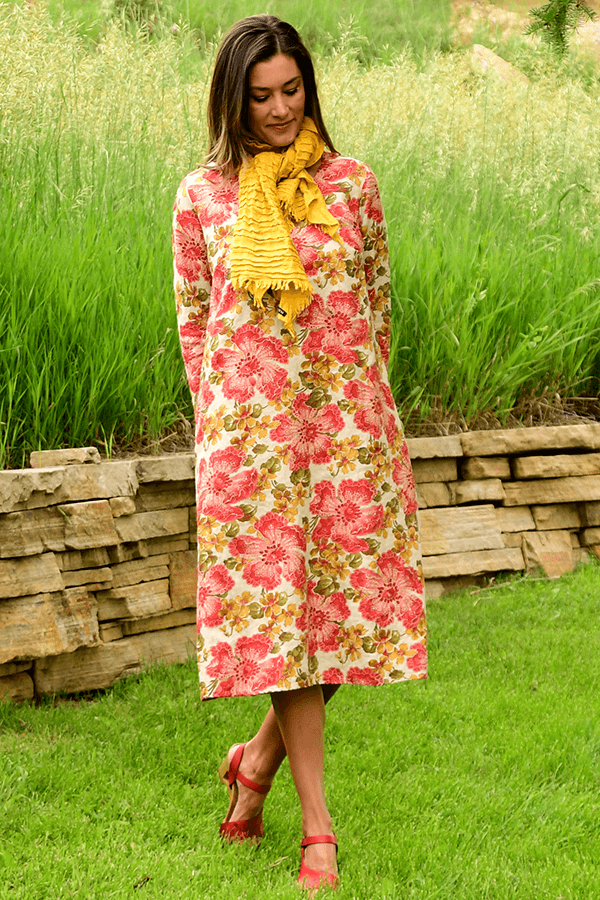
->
[230, 117, 341, 332]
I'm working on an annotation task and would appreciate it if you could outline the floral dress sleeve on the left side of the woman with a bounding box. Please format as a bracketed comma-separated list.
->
[173, 179, 212, 402]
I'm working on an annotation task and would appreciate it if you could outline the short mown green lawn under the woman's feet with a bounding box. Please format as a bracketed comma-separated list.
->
[0, 564, 600, 900]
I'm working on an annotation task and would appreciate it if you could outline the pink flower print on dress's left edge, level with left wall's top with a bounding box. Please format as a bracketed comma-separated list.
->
[198, 447, 258, 522]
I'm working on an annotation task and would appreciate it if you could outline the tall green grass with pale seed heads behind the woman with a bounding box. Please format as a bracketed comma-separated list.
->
[0, 6, 600, 466]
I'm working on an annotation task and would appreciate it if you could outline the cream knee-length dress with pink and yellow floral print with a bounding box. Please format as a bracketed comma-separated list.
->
[173, 152, 427, 699]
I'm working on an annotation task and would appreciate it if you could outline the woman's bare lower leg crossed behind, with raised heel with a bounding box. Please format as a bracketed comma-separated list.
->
[226, 684, 339, 828]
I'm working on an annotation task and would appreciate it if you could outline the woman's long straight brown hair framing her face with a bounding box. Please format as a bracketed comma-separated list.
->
[206, 15, 335, 174]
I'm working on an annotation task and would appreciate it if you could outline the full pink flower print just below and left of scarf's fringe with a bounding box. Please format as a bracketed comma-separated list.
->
[212, 325, 288, 403]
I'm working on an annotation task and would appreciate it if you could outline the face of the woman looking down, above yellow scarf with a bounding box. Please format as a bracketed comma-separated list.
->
[248, 53, 304, 148]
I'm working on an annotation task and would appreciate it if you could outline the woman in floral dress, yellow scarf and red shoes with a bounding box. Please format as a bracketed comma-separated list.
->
[174, 15, 426, 890]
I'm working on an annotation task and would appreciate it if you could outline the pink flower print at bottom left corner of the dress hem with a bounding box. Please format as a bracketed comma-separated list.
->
[206, 635, 284, 697]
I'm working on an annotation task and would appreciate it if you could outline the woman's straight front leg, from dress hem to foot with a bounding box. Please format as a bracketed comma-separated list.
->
[271, 686, 337, 872]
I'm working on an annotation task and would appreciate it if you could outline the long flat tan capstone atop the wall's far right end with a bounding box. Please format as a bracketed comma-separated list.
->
[460, 423, 600, 456]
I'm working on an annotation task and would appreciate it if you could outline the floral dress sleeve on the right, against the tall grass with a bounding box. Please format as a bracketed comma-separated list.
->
[360, 169, 391, 366]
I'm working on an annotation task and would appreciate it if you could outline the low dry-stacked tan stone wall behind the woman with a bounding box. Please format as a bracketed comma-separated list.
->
[0, 424, 600, 700]
